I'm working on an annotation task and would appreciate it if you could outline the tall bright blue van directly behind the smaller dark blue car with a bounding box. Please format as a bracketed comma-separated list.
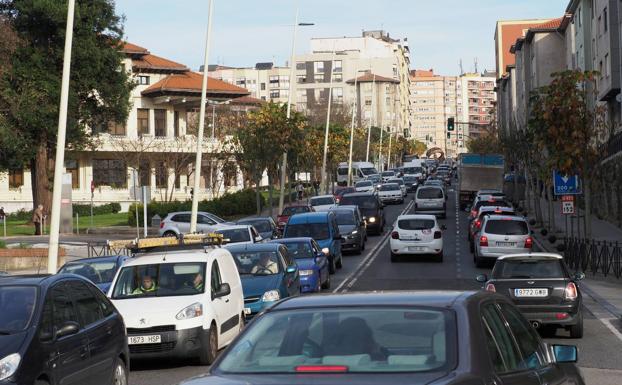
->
[283, 212, 343, 274]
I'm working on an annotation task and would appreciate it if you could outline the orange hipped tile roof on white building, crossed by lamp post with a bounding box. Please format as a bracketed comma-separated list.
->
[142, 71, 249, 96]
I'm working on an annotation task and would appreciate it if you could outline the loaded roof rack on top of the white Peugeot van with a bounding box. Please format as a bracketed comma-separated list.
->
[106, 233, 227, 254]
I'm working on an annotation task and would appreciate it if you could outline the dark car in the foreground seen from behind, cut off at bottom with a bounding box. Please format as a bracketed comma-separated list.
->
[183, 291, 584, 385]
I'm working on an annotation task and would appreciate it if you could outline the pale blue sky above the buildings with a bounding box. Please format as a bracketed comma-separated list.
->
[116, 0, 569, 75]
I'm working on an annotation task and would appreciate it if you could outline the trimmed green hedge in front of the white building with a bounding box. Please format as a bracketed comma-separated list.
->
[128, 189, 265, 226]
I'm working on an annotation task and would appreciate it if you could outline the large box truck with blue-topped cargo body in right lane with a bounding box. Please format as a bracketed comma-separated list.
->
[458, 154, 505, 210]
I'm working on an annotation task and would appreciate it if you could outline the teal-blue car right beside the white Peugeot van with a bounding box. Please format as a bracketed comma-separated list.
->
[225, 243, 300, 319]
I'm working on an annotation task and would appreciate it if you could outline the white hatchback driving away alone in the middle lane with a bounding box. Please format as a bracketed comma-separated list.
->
[389, 214, 445, 262]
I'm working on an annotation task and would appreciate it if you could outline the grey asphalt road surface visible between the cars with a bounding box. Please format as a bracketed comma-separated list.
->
[130, 188, 622, 385]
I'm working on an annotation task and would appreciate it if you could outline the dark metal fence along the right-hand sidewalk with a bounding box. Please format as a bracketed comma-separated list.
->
[564, 238, 622, 278]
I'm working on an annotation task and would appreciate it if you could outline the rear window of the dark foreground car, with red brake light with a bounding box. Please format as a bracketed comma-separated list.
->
[216, 307, 457, 374]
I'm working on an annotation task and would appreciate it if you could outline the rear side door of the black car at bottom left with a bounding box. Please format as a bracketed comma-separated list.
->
[66, 281, 119, 385]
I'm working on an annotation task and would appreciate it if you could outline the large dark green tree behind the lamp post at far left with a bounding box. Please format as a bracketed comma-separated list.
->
[0, 0, 134, 213]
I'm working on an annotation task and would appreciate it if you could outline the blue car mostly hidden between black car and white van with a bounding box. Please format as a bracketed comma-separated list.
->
[57, 255, 129, 293]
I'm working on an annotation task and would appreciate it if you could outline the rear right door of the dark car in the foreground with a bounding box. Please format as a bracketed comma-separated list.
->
[481, 302, 541, 385]
